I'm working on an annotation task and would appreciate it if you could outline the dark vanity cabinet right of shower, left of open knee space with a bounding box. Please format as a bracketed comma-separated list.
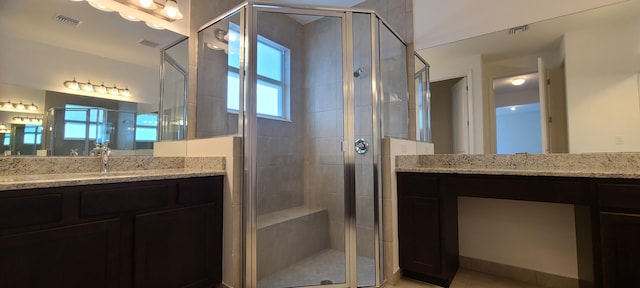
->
[398, 173, 458, 287]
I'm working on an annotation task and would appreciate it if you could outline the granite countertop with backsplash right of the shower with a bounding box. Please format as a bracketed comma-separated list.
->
[396, 153, 640, 179]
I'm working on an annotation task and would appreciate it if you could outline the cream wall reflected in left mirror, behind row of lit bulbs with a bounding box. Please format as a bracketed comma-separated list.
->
[0, 35, 160, 105]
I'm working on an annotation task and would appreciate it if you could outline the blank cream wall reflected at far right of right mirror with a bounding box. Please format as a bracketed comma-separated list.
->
[565, 17, 640, 153]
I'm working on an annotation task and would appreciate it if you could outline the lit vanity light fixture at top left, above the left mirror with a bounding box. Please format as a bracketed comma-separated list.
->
[73, 0, 183, 30]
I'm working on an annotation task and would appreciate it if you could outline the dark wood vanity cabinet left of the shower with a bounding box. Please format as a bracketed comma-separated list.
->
[0, 176, 223, 288]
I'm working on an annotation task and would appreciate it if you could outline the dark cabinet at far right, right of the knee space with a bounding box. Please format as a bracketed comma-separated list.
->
[597, 181, 640, 287]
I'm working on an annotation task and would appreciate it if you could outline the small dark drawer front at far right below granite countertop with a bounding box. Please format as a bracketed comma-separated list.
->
[598, 183, 640, 210]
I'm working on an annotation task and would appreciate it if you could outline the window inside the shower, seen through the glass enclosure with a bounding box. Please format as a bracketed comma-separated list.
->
[227, 24, 291, 120]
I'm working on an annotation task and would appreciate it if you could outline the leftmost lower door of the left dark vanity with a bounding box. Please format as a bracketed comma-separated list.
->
[0, 220, 120, 288]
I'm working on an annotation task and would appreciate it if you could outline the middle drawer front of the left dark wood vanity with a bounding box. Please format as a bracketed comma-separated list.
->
[80, 183, 169, 217]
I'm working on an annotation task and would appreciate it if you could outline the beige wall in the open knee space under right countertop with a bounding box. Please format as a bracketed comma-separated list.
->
[458, 197, 578, 278]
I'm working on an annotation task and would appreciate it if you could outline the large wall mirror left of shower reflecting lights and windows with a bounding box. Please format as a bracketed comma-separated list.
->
[0, 0, 188, 156]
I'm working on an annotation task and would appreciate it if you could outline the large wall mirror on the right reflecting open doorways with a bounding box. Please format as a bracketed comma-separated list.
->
[418, 0, 640, 154]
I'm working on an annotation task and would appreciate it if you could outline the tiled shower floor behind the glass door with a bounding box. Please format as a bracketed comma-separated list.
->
[258, 249, 375, 288]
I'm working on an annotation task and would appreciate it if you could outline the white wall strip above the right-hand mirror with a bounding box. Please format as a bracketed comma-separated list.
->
[413, 0, 624, 50]
